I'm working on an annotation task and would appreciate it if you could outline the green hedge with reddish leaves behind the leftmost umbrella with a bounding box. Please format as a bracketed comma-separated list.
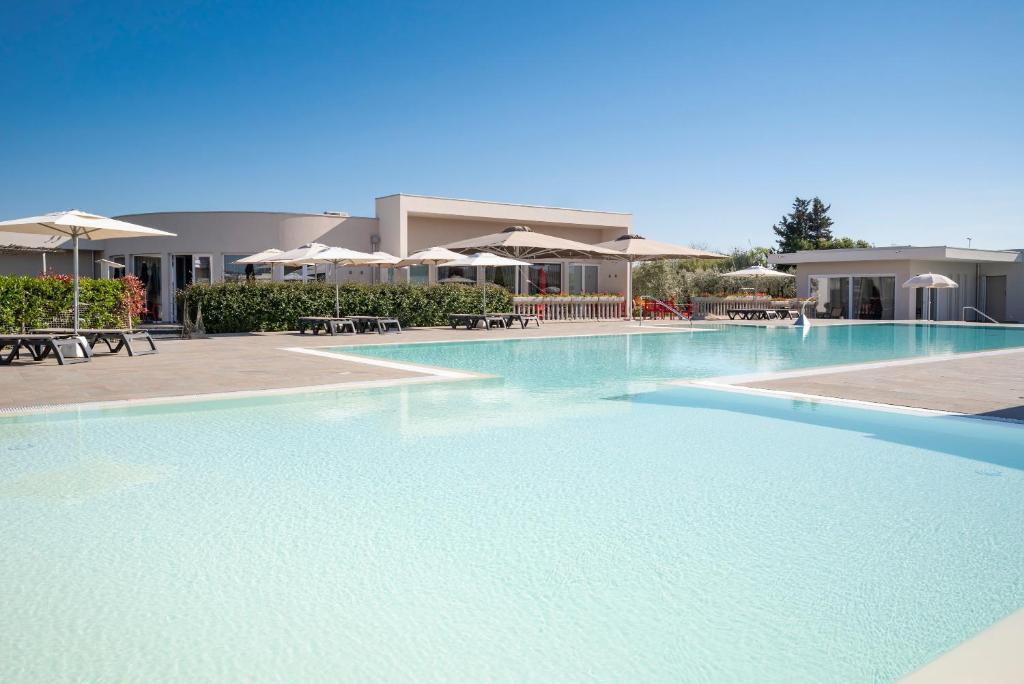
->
[0, 275, 125, 333]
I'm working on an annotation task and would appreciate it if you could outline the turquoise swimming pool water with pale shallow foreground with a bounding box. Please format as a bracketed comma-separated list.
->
[0, 326, 1024, 682]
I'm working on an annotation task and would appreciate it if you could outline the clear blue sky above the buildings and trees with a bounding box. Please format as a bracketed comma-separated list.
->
[0, 0, 1024, 249]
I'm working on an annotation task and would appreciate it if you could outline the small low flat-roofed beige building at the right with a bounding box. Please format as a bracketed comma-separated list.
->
[768, 246, 1024, 323]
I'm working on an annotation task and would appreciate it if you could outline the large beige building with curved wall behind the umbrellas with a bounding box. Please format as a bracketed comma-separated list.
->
[0, 195, 632, 320]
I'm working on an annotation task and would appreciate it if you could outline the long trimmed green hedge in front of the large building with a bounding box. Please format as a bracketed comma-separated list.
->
[178, 283, 512, 333]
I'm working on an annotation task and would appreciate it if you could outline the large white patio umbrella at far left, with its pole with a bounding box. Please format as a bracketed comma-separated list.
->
[0, 209, 175, 333]
